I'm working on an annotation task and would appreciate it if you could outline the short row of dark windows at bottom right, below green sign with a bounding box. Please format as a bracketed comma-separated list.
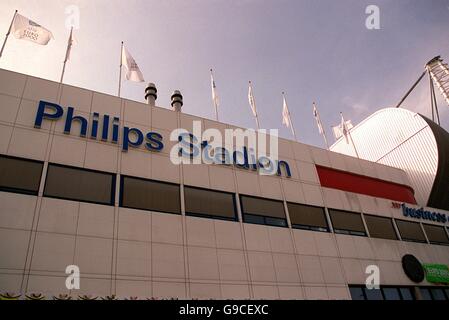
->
[349, 286, 449, 300]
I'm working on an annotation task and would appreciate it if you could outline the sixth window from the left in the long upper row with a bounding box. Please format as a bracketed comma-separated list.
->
[287, 202, 329, 232]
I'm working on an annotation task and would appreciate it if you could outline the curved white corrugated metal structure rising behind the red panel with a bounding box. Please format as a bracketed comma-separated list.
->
[331, 108, 438, 206]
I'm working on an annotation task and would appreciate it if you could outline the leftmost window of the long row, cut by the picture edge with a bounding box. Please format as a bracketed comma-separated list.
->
[0, 156, 44, 195]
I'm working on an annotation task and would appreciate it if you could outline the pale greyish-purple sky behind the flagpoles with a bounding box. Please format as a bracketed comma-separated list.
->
[0, 0, 449, 147]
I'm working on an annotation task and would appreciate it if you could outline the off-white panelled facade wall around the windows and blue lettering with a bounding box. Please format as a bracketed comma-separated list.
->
[0, 70, 449, 299]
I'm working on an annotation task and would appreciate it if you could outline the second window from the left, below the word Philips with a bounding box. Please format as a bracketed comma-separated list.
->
[44, 164, 115, 205]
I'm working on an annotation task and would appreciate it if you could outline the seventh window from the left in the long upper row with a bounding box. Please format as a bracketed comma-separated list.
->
[329, 209, 366, 236]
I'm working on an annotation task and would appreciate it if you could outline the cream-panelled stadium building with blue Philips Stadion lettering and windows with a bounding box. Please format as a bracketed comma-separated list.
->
[0, 70, 449, 299]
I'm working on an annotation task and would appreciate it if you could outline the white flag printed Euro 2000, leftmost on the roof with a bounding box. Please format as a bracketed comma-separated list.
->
[12, 13, 53, 45]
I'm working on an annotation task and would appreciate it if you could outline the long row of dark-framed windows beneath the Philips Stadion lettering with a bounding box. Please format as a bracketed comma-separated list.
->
[0, 156, 449, 244]
